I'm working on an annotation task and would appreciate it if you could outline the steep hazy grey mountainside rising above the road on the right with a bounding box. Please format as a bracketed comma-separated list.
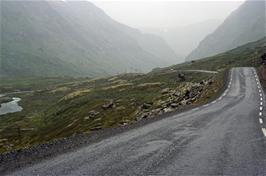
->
[186, 1, 266, 60]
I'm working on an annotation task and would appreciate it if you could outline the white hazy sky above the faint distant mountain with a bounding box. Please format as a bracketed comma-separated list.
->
[93, 0, 243, 28]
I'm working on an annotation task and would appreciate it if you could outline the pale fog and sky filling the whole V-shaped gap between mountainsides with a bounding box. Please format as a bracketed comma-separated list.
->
[92, 0, 244, 57]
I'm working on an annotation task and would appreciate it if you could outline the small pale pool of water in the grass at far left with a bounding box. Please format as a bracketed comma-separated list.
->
[0, 95, 23, 115]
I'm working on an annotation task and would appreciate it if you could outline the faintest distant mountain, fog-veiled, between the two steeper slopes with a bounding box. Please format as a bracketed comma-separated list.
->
[142, 20, 221, 58]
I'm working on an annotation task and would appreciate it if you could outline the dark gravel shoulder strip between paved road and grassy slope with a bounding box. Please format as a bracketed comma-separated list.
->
[0, 69, 231, 174]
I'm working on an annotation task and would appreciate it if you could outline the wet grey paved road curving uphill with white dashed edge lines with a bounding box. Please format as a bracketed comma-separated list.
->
[6, 68, 266, 176]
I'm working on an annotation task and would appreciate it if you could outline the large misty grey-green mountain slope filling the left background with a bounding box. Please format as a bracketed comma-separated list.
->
[0, 1, 177, 77]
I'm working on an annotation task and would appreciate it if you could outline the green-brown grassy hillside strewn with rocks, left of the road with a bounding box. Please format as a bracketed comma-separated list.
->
[0, 38, 266, 152]
